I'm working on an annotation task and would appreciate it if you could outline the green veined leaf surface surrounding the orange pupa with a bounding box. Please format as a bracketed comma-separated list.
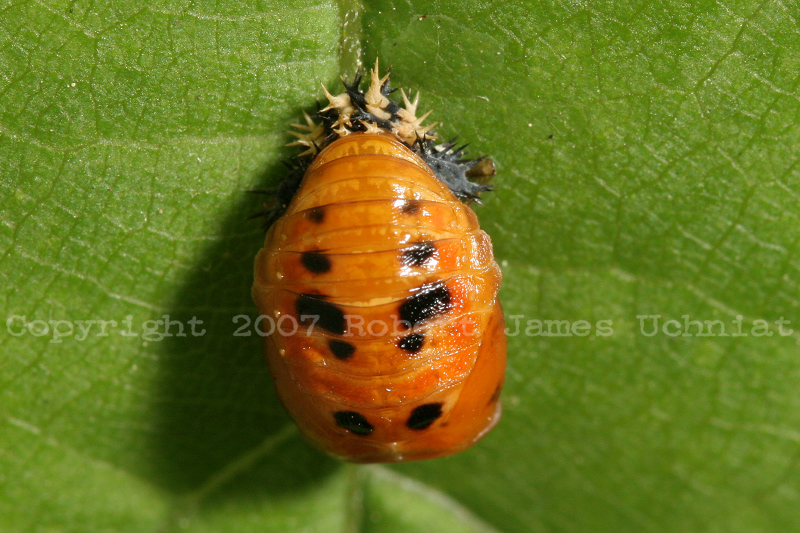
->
[0, 0, 800, 533]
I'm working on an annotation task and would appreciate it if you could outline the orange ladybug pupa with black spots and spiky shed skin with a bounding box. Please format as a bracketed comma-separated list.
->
[253, 62, 506, 463]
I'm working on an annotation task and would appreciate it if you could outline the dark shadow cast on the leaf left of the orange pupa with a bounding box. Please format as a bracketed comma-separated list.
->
[148, 140, 338, 501]
